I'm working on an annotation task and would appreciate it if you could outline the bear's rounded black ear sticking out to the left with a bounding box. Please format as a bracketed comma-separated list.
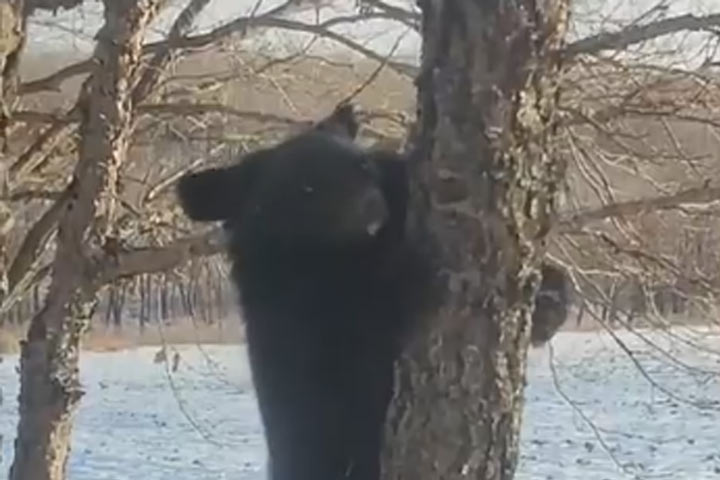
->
[177, 159, 262, 222]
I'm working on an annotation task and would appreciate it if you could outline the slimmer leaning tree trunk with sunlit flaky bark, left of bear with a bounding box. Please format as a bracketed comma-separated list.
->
[10, 0, 163, 480]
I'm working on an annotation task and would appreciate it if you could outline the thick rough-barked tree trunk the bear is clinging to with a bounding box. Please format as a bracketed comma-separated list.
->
[383, 0, 570, 480]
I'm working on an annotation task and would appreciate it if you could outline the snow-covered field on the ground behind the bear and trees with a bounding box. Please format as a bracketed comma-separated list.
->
[0, 330, 720, 480]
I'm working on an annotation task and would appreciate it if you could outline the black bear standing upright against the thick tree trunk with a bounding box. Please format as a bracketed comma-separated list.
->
[178, 106, 433, 480]
